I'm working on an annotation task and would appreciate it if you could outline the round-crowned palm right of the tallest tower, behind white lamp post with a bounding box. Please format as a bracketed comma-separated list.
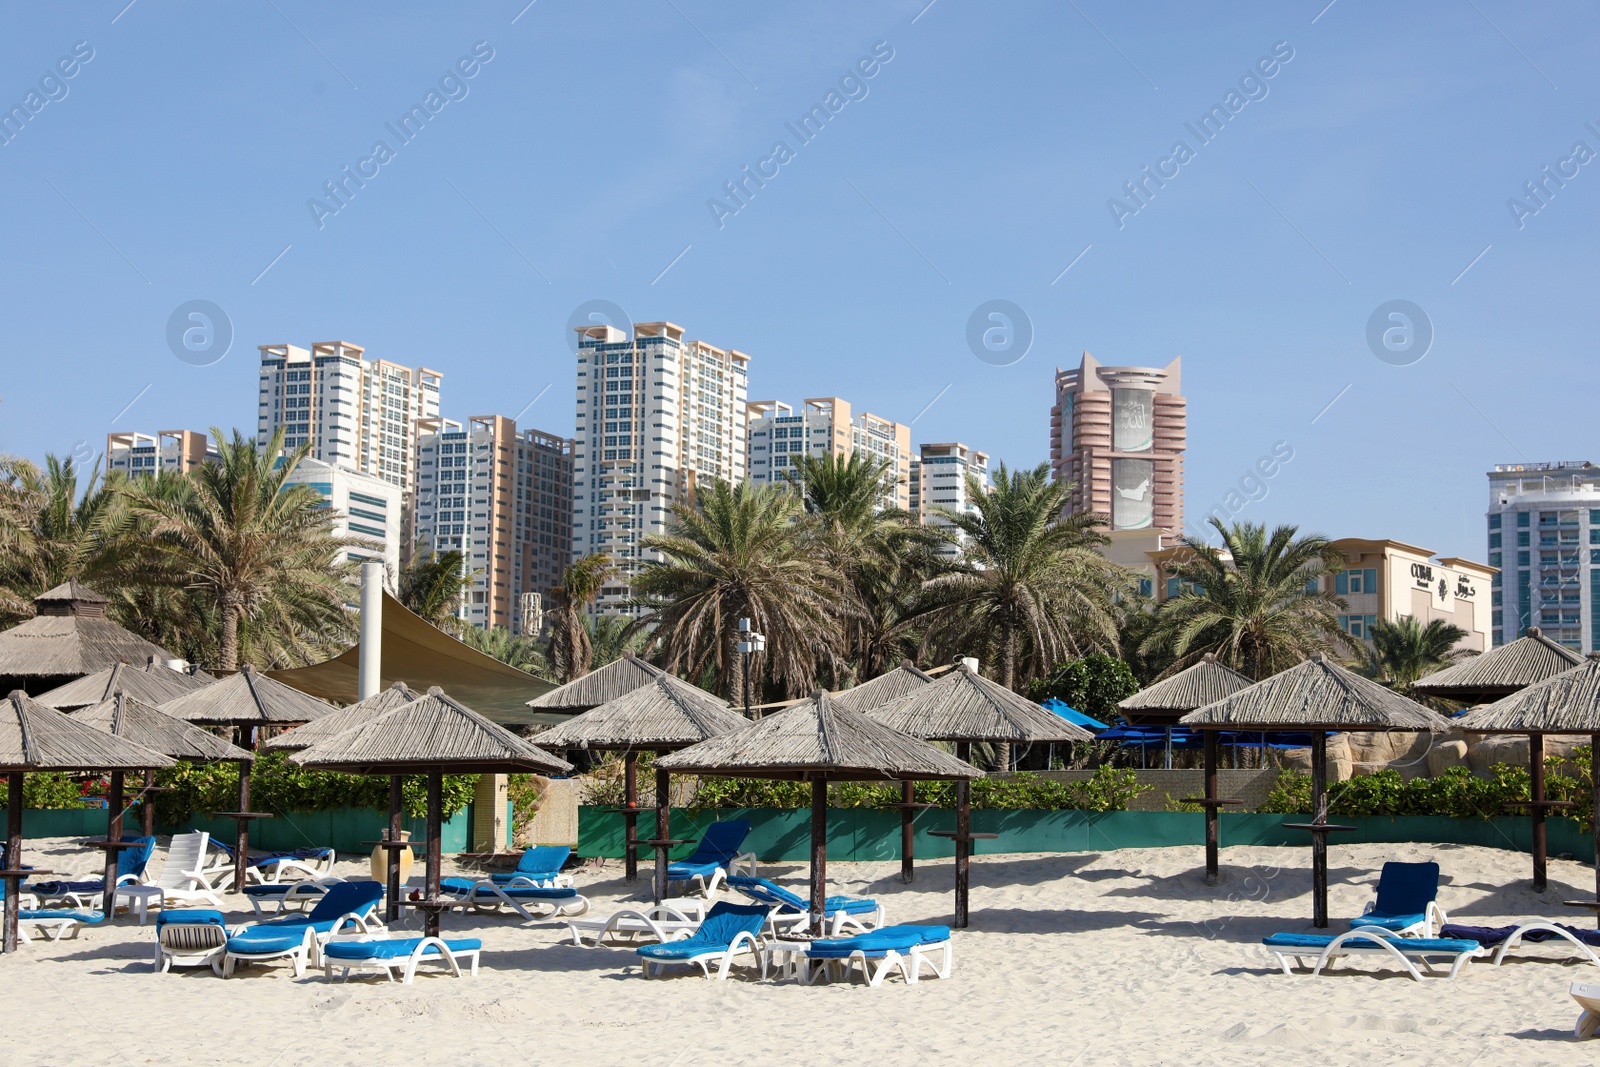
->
[634, 482, 840, 702]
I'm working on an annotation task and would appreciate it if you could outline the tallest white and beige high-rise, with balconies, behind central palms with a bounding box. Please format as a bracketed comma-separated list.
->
[571, 322, 750, 613]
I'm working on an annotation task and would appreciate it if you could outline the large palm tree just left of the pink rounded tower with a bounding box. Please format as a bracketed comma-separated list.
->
[922, 464, 1131, 689]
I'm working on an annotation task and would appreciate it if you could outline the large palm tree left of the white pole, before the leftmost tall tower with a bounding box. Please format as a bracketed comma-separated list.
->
[125, 427, 360, 670]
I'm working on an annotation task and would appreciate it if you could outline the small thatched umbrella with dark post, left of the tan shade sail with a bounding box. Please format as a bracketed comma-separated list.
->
[160, 664, 339, 893]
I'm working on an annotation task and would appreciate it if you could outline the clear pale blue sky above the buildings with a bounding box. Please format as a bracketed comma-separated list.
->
[0, 0, 1600, 558]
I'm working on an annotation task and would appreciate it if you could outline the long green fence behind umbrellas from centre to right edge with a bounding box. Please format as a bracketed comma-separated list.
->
[578, 806, 1594, 862]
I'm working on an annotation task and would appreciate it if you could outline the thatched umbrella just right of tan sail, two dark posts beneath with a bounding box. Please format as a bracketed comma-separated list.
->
[538, 672, 749, 904]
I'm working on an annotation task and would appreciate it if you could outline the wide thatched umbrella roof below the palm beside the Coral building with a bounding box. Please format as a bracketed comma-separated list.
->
[1179, 654, 1446, 731]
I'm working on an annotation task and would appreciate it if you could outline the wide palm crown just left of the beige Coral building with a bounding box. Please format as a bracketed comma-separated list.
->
[1139, 517, 1358, 680]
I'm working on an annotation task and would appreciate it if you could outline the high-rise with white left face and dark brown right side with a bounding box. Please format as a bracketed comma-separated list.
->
[411, 414, 573, 633]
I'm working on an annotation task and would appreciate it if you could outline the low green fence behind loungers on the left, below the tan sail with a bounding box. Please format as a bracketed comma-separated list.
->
[0, 805, 472, 853]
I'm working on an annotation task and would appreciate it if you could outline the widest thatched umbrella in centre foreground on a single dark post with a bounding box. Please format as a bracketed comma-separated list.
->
[658, 693, 982, 934]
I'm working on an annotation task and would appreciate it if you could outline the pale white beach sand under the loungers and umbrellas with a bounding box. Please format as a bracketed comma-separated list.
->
[0, 841, 1600, 1067]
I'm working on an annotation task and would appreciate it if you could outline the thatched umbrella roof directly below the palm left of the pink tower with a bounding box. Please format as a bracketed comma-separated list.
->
[867, 664, 1094, 744]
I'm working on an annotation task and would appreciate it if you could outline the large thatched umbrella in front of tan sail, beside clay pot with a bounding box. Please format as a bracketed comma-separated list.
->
[290, 686, 573, 937]
